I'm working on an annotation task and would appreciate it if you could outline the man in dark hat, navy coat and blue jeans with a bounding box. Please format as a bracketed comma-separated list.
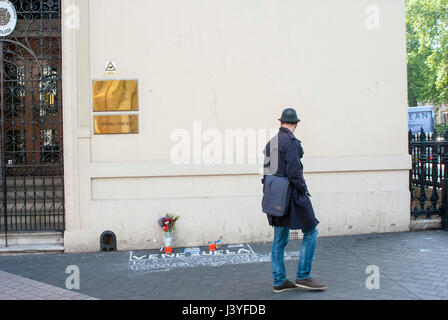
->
[263, 109, 326, 292]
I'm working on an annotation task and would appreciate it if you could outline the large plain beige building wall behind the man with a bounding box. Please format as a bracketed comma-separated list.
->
[63, 0, 410, 252]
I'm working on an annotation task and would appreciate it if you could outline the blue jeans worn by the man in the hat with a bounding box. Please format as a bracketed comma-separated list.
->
[272, 227, 319, 287]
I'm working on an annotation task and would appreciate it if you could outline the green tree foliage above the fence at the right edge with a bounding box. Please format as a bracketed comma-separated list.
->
[406, 0, 448, 106]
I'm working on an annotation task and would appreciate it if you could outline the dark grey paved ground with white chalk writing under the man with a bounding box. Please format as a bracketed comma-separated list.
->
[0, 230, 448, 300]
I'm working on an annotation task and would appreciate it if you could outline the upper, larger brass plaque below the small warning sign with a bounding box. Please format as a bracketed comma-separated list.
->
[93, 80, 138, 112]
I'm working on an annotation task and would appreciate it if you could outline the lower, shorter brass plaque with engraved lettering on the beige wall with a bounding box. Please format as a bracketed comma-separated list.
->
[94, 115, 138, 134]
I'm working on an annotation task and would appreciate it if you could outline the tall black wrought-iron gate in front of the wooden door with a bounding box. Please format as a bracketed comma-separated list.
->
[0, 0, 65, 246]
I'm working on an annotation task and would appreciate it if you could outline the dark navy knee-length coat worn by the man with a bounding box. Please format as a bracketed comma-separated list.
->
[263, 127, 319, 230]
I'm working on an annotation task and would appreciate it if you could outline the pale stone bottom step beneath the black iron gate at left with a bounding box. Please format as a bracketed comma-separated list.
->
[0, 231, 64, 246]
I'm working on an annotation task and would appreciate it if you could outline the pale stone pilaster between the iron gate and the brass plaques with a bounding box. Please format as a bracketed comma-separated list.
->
[62, 0, 91, 252]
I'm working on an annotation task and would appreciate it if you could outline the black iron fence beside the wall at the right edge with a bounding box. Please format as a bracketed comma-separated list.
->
[409, 129, 448, 230]
